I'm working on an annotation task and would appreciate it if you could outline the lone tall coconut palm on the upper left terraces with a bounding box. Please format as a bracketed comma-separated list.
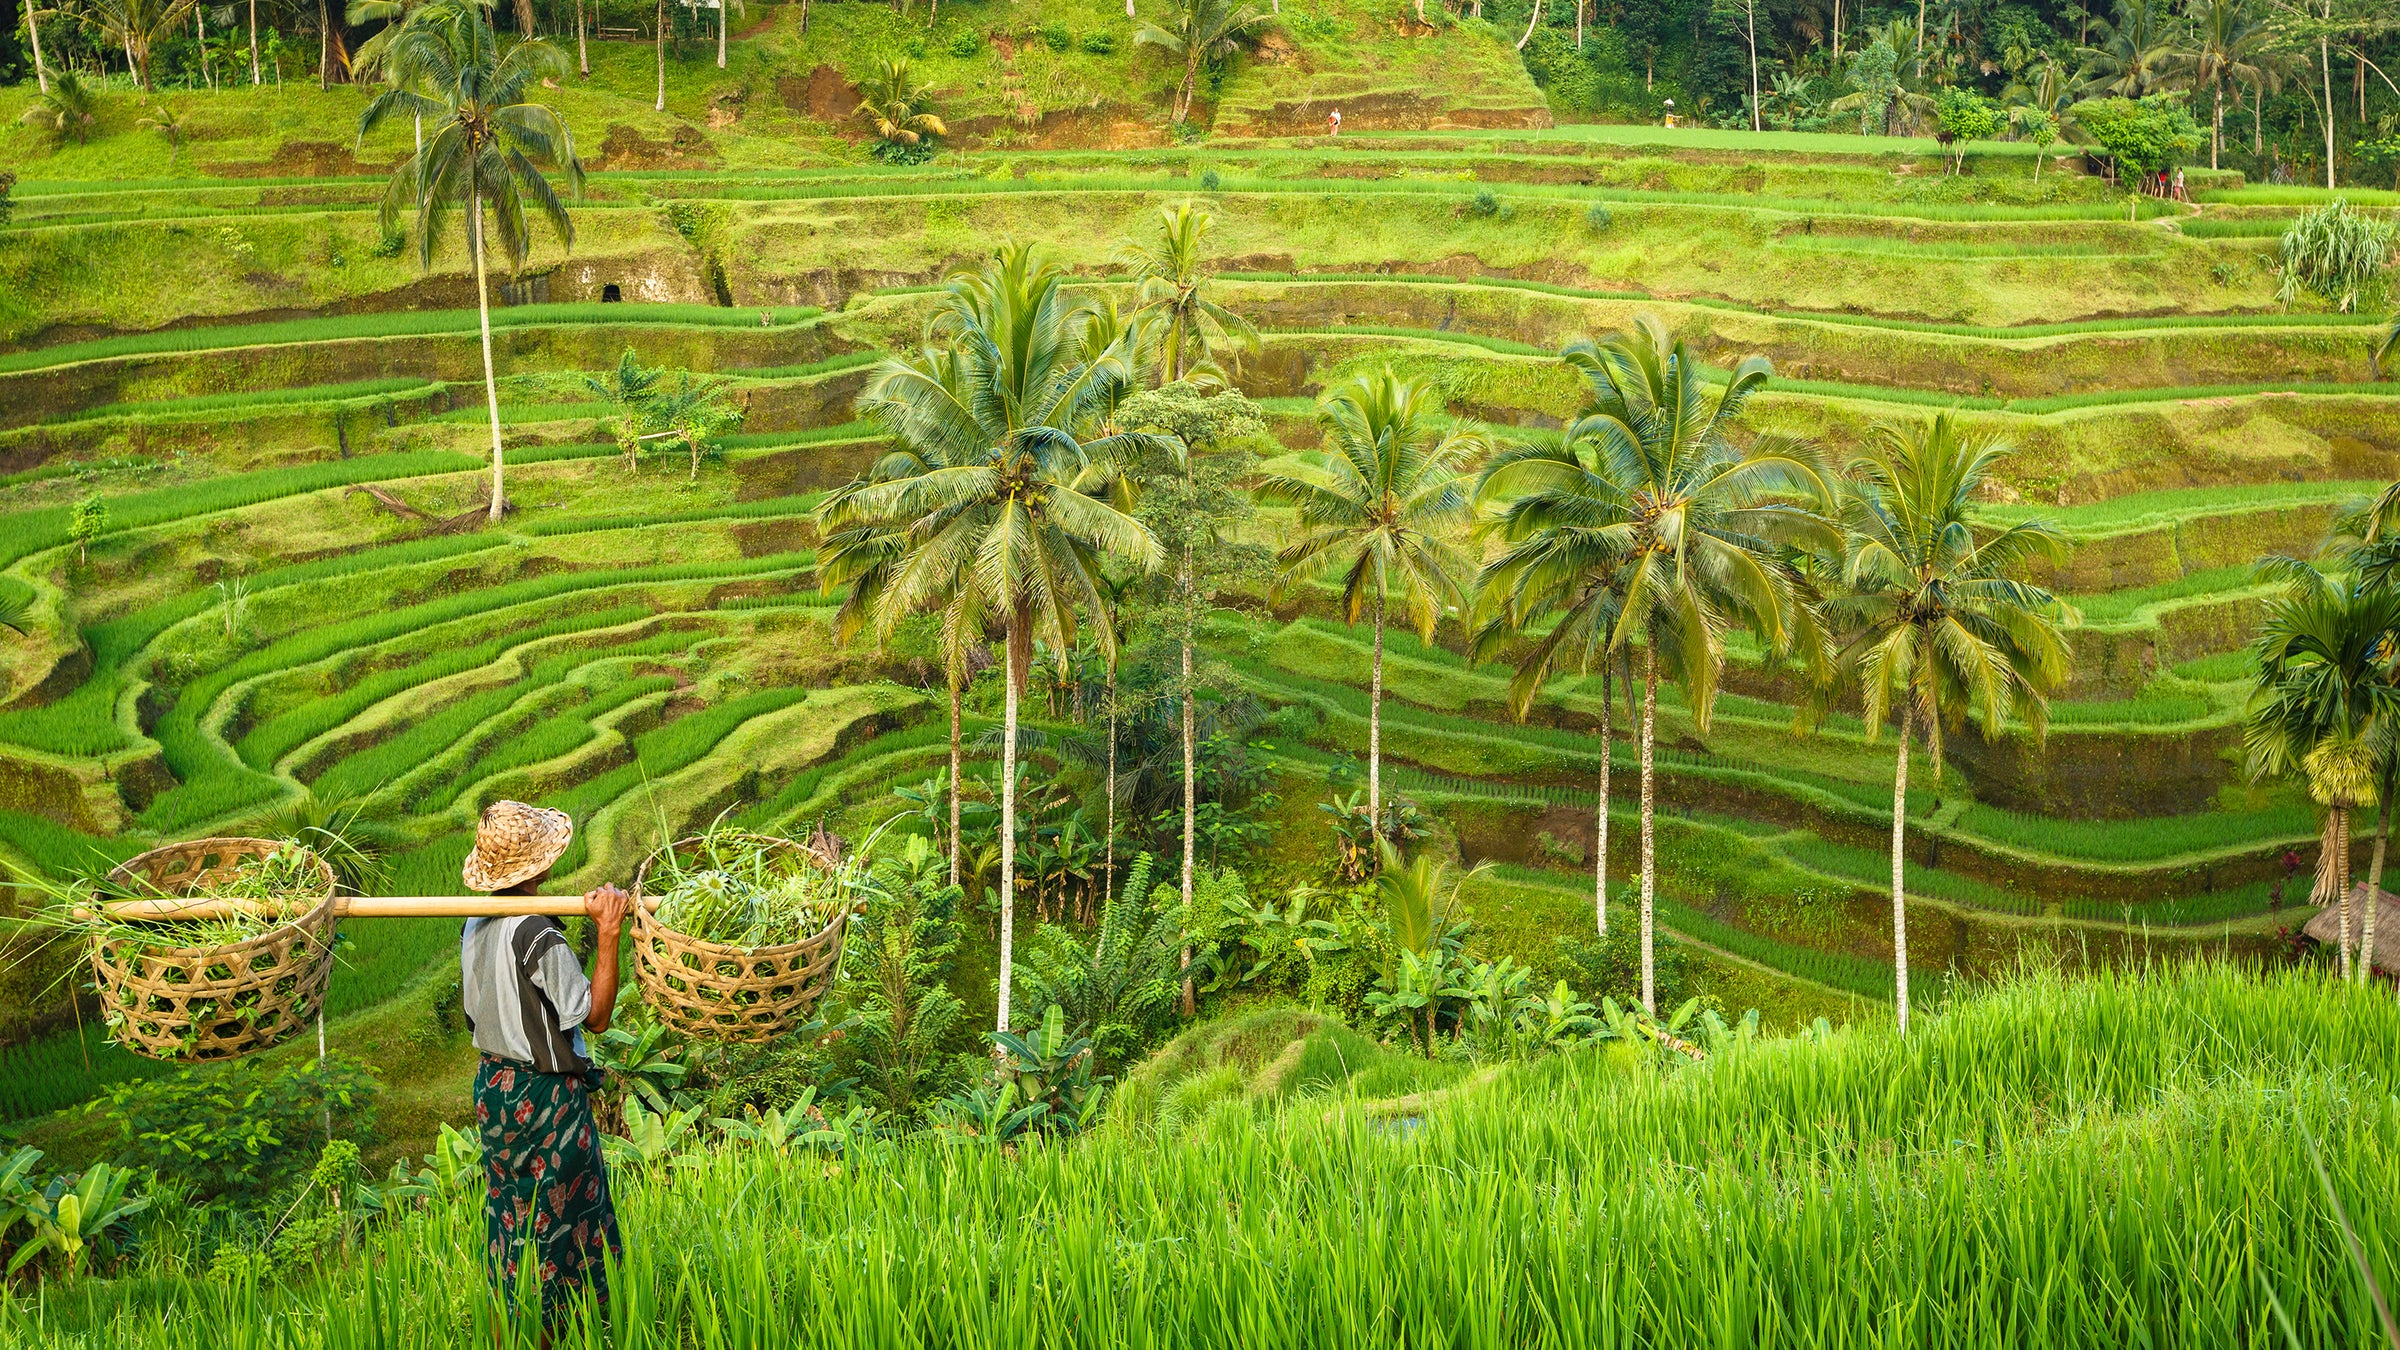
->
[358, 0, 583, 521]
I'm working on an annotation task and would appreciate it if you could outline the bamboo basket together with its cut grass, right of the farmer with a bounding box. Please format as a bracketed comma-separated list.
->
[634, 817, 864, 1040]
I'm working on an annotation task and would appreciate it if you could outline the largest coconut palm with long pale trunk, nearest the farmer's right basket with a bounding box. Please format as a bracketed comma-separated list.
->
[821, 247, 1159, 1031]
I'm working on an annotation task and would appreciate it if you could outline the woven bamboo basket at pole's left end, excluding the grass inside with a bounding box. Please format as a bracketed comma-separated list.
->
[91, 838, 334, 1062]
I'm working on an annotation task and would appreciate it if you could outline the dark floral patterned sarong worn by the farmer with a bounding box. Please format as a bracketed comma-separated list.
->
[475, 1055, 624, 1321]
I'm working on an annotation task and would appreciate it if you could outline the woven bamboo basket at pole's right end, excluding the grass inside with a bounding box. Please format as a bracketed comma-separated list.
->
[634, 836, 850, 1040]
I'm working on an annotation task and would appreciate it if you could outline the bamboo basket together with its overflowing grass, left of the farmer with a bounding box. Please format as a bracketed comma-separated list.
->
[14, 838, 334, 1062]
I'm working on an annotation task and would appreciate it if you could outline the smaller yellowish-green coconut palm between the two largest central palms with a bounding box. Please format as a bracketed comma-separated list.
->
[1258, 368, 1490, 850]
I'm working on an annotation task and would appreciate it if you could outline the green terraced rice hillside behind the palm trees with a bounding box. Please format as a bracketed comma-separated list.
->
[0, 2, 2400, 1153]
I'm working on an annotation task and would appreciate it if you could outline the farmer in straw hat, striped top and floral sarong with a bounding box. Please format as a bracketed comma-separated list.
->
[458, 802, 629, 1326]
